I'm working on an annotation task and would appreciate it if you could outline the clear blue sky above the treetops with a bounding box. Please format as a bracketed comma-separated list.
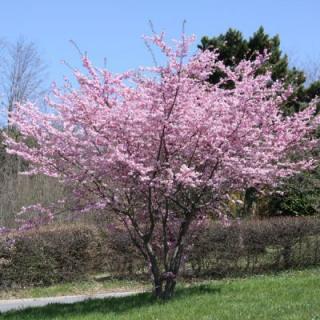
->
[0, 0, 320, 82]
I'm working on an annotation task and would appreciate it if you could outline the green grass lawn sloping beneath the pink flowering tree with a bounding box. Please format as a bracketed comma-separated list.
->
[0, 269, 320, 320]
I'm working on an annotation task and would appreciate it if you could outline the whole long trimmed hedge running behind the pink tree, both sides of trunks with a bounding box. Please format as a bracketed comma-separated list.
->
[0, 217, 320, 288]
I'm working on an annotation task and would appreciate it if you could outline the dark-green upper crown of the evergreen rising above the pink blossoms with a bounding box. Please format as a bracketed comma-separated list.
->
[198, 27, 320, 114]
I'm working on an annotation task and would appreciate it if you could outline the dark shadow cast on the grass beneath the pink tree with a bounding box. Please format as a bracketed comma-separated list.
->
[0, 285, 220, 320]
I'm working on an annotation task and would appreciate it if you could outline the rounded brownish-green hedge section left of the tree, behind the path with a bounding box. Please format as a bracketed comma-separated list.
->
[0, 225, 101, 287]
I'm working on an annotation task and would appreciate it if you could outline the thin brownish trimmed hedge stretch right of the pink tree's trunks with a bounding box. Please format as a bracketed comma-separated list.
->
[187, 217, 320, 277]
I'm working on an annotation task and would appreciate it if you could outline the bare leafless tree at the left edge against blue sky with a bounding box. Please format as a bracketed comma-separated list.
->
[0, 38, 46, 225]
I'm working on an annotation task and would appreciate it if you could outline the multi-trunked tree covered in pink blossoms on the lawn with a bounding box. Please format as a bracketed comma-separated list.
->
[6, 34, 319, 298]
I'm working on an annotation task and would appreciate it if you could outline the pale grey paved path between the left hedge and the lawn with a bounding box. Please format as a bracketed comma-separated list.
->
[0, 291, 141, 313]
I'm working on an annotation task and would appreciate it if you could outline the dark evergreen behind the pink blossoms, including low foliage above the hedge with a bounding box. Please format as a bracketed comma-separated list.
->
[198, 27, 320, 215]
